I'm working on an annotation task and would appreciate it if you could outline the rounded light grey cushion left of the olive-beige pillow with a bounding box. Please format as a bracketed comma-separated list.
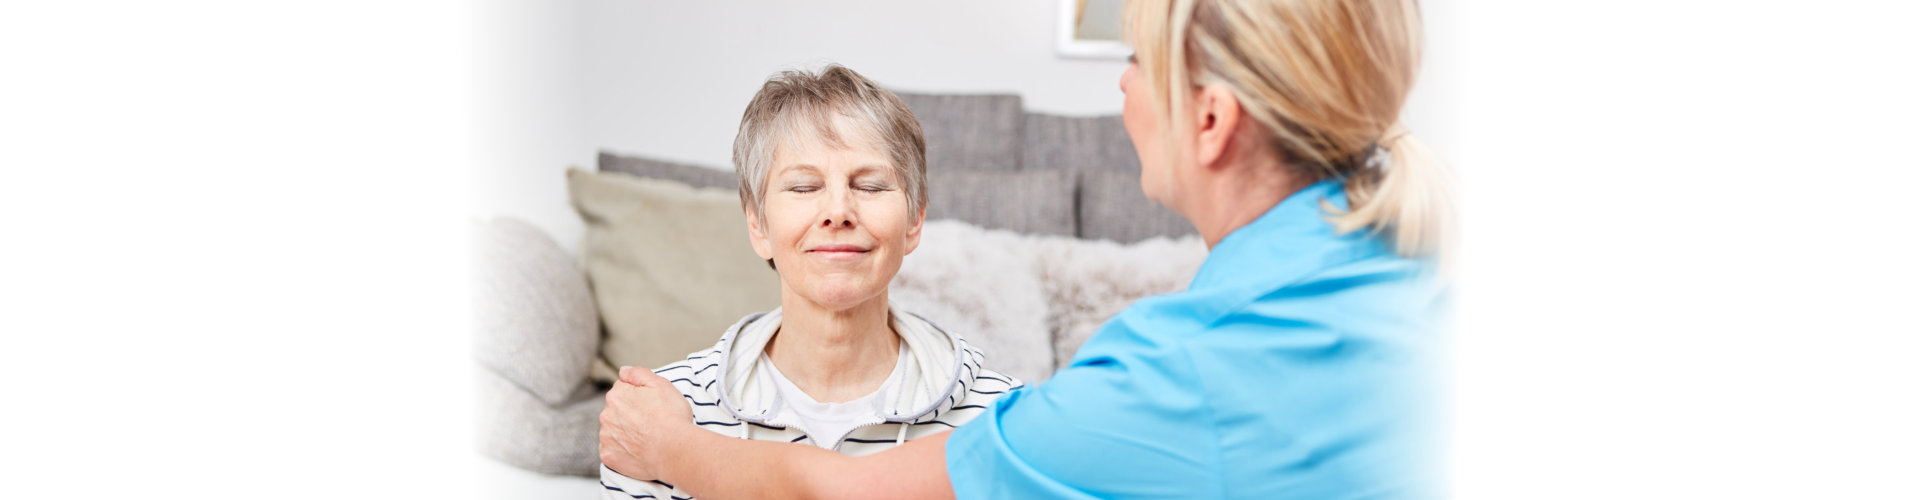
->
[470, 219, 599, 404]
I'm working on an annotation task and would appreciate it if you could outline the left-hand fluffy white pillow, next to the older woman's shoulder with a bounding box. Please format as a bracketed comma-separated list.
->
[887, 221, 1054, 383]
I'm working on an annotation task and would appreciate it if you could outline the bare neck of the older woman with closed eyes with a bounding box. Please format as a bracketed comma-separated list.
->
[766, 290, 900, 402]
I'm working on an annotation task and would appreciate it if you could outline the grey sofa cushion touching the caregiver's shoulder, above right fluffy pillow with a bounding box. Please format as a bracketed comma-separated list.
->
[1077, 169, 1196, 242]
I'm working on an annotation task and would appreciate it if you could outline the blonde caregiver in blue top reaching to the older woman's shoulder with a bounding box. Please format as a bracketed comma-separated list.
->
[601, 0, 1450, 498]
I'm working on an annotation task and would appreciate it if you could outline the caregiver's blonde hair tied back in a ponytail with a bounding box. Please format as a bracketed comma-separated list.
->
[1125, 0, 1452, 258]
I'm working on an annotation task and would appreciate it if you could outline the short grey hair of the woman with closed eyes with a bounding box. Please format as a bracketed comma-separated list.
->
[733, 63, 927, 221]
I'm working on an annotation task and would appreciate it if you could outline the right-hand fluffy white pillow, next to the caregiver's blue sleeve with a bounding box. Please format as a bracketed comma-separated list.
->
[1033, 237, 1208, 367]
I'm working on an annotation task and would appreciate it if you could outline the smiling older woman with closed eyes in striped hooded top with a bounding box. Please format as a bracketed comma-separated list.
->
[601, 65, 1021, 498]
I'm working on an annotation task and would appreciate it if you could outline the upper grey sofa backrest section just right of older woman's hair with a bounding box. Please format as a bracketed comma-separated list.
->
[899, 92, 1023, 171]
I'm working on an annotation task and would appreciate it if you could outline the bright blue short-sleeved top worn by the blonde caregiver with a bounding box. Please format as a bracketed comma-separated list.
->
[947, 181, 1444, 498]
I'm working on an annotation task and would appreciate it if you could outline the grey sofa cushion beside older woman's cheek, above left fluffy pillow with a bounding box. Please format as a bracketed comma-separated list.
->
[927, 169, 1077, 237]
